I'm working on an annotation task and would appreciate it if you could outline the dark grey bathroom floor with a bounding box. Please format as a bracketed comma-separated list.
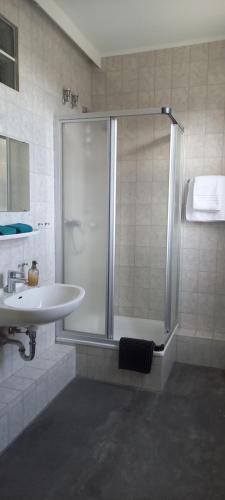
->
[0, 365, 225, 500]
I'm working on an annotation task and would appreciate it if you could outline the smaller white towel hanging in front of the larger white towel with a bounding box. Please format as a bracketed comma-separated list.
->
[193, 175, 222, 212]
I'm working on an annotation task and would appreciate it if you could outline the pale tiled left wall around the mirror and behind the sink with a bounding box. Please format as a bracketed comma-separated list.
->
[0, 0, 91, 382]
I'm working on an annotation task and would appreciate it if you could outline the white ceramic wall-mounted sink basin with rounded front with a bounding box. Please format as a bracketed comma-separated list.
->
[0, 283, 85, 327]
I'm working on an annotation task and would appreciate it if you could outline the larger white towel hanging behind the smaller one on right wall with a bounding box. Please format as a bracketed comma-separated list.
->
[186, 175, 225, 222]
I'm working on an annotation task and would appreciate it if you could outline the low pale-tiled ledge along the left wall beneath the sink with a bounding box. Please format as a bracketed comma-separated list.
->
[0, 345, 75, 452]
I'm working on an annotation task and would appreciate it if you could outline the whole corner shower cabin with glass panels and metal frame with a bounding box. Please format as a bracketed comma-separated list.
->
[56, 108, 183, 345]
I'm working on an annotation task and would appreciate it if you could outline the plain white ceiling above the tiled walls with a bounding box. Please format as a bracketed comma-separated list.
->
[38, 0, 225, 63]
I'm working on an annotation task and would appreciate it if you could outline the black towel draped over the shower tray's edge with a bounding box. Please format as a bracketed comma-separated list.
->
[119, 337, 155, 373]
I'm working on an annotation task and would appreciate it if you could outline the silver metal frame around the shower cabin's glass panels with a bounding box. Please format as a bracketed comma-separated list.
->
[55, 107, 184, 345]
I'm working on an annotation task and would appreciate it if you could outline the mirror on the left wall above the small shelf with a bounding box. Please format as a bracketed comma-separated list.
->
[0, 136, 30, 212]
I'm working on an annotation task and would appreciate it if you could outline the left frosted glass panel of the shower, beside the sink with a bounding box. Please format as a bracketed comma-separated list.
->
[62, 118, 110, 336]
